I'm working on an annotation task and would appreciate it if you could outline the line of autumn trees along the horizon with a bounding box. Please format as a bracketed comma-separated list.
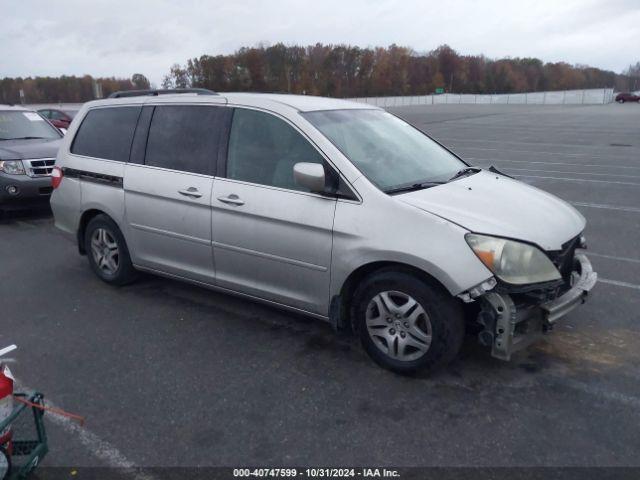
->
[0, 43, 640, 103]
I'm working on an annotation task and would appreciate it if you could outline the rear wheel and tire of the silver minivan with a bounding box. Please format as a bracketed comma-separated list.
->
[84, 214, 137, 285]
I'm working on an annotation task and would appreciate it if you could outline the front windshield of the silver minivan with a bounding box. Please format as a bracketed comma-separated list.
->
[304, 110, 466, 191]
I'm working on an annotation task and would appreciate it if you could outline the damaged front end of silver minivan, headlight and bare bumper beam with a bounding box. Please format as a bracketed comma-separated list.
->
[458, 234, 597, 360]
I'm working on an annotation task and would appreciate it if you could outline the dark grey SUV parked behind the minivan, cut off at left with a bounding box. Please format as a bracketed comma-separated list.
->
[0, 105, 62, 213]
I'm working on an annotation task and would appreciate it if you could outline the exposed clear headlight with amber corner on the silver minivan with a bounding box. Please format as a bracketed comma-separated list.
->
[465, 233, 562, 285]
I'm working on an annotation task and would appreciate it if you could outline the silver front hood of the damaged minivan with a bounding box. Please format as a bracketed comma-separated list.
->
[396, 170, 586, 250]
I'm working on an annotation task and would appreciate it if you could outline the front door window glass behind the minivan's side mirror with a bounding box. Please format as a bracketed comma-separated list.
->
[227, 108, 324, 191]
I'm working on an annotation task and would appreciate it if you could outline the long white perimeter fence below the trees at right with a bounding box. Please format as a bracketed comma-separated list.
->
[346, 88, 613, 107]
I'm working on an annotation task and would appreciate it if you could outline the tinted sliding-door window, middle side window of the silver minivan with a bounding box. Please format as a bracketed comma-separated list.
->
[145, 105, 224, 175]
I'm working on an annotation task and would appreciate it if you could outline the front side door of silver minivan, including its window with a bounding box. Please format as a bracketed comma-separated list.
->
[211, 108, 336, 315]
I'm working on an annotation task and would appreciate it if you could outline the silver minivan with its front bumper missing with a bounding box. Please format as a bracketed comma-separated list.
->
[51, 90, 597, 372]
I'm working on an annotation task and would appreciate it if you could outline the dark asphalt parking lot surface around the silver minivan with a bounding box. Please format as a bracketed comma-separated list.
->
[0, 104, 640, 467]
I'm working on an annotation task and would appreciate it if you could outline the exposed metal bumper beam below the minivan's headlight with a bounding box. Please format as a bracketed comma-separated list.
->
[478, 254, 598, 360]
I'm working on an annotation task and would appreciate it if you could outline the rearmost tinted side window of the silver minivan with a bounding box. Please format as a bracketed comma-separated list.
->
[71, 107, 140, 162]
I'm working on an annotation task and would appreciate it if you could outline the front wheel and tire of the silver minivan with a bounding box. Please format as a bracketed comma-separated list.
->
[352, 269, 464, 373]
